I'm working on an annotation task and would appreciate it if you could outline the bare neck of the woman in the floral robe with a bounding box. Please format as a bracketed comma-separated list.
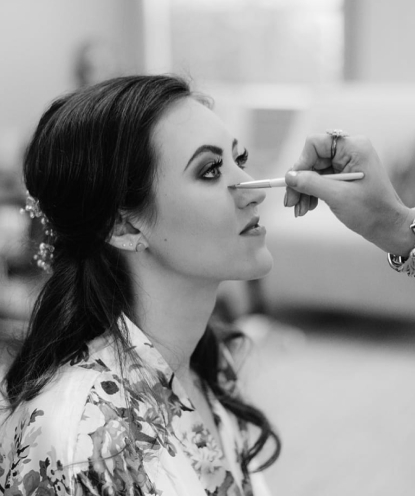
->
[129, 262, 218, 382]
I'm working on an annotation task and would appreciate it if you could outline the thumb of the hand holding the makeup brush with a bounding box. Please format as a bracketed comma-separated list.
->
[285, 171, 344, 205]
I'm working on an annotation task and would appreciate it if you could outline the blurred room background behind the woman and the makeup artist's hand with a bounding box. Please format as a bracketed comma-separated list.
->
[0, 0, 415, 496]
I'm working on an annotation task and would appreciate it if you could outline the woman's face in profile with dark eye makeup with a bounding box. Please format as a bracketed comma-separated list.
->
[141, 98, 272, 282]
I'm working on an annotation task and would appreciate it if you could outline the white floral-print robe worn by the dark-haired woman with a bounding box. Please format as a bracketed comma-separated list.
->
[0, 320, 272, 496]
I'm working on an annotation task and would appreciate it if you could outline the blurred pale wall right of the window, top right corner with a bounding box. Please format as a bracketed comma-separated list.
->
[344, 0, 415, 83]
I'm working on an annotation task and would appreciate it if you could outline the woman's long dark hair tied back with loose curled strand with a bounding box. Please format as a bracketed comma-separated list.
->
[5, 76, 279, 467]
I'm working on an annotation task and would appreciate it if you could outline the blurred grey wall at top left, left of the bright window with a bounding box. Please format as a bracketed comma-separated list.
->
[0, 0, 142, 132]
